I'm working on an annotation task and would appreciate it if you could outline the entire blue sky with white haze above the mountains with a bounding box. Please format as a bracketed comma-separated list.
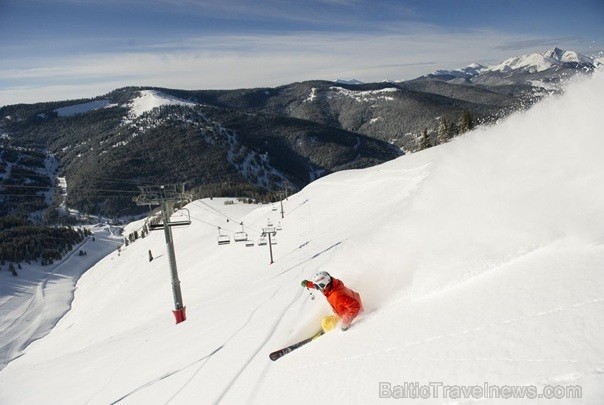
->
[0, 0, 604, 106]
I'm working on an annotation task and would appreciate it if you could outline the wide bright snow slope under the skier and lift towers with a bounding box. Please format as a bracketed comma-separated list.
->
[0, 73, 604, 405]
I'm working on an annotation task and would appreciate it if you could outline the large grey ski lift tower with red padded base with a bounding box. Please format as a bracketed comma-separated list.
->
[133, 184, 191, 324]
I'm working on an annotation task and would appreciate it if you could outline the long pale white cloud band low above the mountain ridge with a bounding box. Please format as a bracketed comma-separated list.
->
[0, 27, 596, 106]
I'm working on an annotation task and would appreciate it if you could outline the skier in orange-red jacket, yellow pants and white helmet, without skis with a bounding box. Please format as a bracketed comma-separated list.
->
[301, 271, 363, 332]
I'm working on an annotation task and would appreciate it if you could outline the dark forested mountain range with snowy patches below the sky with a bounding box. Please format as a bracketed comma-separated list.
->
[0, 48, 598, 218]
